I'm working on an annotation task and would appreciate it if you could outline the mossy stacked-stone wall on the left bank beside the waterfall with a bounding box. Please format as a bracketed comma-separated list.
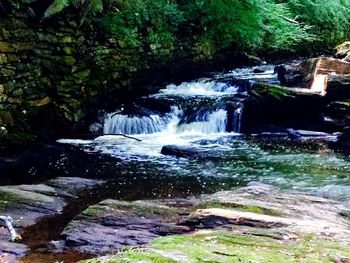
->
[0, 10, 245, 155]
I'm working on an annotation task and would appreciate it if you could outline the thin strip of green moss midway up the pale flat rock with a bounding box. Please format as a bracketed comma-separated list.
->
[195, 200, 283, 216]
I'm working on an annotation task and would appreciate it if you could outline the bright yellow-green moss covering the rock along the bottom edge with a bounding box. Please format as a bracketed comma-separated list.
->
[80, 232, 350, 263]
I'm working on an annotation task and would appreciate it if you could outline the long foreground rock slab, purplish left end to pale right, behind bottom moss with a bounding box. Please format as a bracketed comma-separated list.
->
[58, 183, 350, 255]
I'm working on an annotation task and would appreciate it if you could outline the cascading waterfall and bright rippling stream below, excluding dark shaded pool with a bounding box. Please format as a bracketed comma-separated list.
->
[59, 66, 350, 200]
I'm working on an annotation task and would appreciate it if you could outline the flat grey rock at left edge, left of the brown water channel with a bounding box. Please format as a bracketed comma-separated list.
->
[0, 177, 103, 256]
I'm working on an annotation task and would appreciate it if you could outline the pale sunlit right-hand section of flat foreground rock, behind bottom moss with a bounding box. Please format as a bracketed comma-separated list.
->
[187, 183, 350, 241]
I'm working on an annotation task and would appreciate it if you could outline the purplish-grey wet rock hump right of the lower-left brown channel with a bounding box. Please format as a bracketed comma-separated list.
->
[62, 199, 189, 255]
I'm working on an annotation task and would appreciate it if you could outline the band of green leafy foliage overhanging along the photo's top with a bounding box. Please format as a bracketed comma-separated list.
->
[4, 0, 350, 54]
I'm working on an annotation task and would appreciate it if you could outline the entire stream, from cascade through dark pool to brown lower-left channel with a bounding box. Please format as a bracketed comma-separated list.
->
[5, 66, 350, 262]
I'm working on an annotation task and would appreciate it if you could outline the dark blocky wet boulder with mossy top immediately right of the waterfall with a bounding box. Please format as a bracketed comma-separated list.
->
[241, 84, 327, 133]
